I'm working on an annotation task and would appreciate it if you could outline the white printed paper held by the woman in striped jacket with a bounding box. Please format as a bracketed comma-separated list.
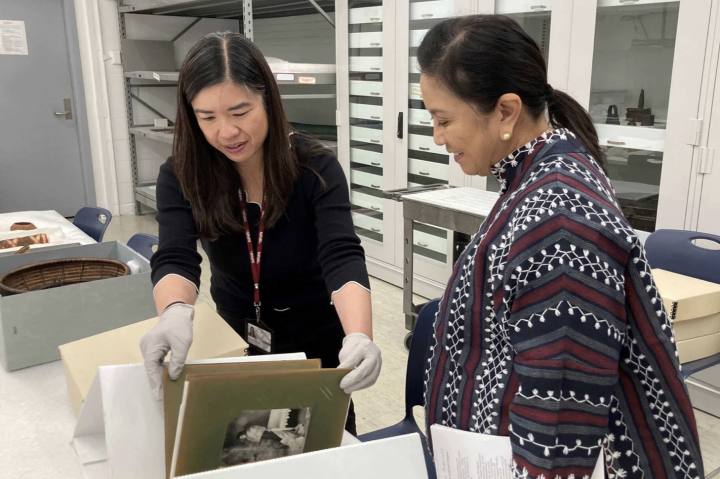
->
[430, 424, 605, 479]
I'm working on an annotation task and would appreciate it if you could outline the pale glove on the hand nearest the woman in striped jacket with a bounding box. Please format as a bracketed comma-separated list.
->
[338, 333, 382, 394]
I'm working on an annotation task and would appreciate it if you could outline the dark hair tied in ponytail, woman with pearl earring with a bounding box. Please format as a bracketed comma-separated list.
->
[418, 15, 605, 166]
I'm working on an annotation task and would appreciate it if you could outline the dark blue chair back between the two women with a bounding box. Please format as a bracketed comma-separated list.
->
[405, 299, 440, 417]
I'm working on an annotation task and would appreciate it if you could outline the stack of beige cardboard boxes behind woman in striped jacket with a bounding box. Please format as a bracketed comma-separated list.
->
[653, 269, 720, 363]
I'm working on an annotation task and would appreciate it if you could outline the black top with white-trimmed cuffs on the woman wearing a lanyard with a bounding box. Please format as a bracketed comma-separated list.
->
[152, 155, 370, 317]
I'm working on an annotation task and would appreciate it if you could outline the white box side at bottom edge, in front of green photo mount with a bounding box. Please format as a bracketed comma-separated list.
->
[181, 433, 428, 479]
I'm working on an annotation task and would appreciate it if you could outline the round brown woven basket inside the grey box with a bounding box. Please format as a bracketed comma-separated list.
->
[0, 258, 130, 296]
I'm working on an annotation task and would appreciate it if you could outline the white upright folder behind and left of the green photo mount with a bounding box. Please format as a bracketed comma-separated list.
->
[72, 353, 310, 479]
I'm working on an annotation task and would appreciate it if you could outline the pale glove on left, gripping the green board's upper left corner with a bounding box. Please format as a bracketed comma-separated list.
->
[140, 303, 195, 401]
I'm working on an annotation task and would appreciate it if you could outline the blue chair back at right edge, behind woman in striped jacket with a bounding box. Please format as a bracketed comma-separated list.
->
[645, 230, 720, 283]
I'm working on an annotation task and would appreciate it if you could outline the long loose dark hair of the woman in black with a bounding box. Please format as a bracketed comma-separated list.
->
[172, 32, 329, 240]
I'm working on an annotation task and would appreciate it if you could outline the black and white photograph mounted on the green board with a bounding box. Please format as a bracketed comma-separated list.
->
[222, 408, 310, 466]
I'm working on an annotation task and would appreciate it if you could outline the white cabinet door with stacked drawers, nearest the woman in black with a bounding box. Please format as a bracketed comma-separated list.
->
[336, 0, 397, 264]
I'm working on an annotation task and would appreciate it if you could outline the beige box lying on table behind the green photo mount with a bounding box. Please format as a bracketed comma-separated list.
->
[60, 303, 248, 414]
